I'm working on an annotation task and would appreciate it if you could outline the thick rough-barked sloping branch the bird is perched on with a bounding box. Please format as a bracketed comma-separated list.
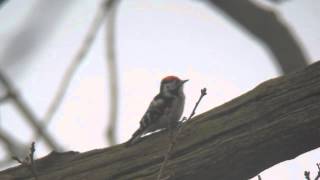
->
[0, 62, 320, 180]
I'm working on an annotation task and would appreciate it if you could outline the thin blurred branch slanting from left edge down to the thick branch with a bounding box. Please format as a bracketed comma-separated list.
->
[0, 71, 59, 149]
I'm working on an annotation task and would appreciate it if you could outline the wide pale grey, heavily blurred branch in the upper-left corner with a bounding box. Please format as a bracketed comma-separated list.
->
[0, 0, 74, 76]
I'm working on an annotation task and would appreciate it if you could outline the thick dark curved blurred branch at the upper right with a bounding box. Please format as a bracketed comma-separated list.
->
[207, 0, 308, 73]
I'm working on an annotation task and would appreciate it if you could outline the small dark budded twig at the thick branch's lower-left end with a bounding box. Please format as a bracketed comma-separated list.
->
[12, 142, 38, 180]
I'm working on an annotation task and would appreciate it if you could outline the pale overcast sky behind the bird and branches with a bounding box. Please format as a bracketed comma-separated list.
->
[0, 0, 320, 180]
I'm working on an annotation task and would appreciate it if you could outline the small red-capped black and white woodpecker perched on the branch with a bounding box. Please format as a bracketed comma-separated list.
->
[127, 76, 188, 145]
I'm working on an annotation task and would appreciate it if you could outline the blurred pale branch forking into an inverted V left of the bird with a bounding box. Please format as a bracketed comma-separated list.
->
[32, 0, 119, 145]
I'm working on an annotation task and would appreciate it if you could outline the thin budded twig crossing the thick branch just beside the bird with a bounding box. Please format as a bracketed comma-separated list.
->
[157, 88, 207, 180]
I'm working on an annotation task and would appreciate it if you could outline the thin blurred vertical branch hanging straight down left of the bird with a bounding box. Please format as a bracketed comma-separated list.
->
[106, 0, 120, 145]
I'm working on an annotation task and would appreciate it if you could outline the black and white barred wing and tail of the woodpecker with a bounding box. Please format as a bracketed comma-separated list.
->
[128, 95, 171, 144]
